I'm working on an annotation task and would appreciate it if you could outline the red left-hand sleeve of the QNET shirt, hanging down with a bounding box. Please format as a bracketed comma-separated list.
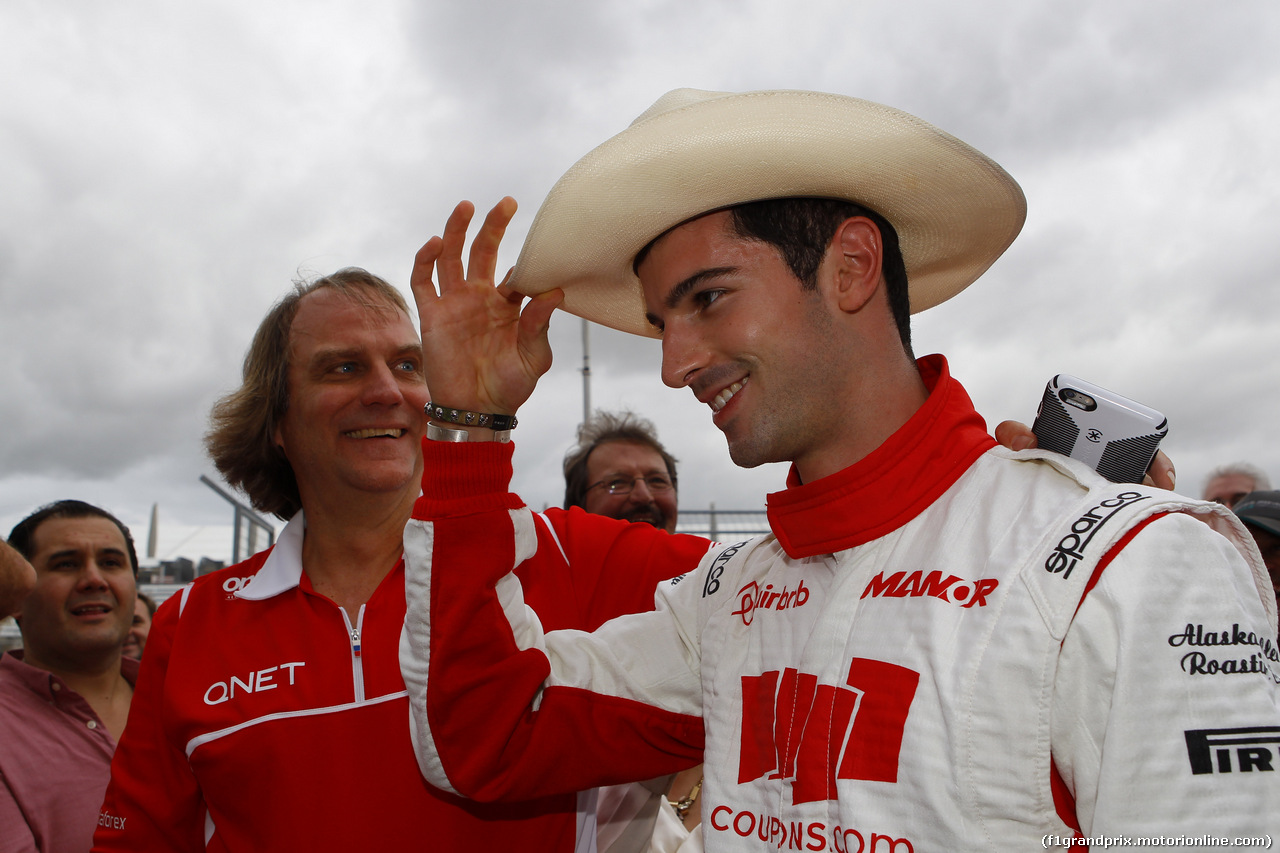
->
[93, 593, 205, 853]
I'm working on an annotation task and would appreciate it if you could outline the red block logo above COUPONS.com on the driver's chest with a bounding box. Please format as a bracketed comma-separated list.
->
[737, 657, 920, 806]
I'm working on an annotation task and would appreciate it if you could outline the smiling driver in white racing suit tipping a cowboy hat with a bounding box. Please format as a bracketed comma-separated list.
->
[401, 90, 1280, 853]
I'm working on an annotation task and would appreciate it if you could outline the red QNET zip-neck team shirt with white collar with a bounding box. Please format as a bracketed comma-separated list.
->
[93, 510, 708, 853]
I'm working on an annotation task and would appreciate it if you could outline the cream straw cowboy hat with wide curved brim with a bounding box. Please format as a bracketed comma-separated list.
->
[511, 88, 1027, 336]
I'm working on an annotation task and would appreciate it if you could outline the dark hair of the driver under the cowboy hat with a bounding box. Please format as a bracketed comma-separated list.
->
[632, 197, 911, 356]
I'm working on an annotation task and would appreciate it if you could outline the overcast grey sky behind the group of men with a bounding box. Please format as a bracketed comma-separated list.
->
[0, 0, 1280, 556]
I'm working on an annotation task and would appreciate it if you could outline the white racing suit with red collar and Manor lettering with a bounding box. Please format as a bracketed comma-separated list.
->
[401, 360, 1280, 853]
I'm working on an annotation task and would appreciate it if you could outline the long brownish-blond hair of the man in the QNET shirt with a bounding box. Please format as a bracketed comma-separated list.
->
[205, 266, 408, 520]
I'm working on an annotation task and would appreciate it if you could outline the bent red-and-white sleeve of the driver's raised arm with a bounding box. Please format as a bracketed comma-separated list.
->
[401, 442, 703, 799]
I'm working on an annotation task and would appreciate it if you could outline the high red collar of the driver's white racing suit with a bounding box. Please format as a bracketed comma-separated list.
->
[765, 355, 996, 558]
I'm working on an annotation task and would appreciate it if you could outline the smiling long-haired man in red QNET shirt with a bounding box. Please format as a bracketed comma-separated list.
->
[95, 269, 707, 853]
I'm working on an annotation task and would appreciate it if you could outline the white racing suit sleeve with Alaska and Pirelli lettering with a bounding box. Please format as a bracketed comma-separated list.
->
[1051, 514, 1280, 847]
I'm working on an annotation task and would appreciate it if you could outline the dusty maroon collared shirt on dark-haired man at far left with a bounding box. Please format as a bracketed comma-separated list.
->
[0, 651, 138, 853]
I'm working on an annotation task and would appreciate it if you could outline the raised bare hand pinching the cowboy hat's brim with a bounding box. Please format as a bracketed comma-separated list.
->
[410, 196, 563, 415]
